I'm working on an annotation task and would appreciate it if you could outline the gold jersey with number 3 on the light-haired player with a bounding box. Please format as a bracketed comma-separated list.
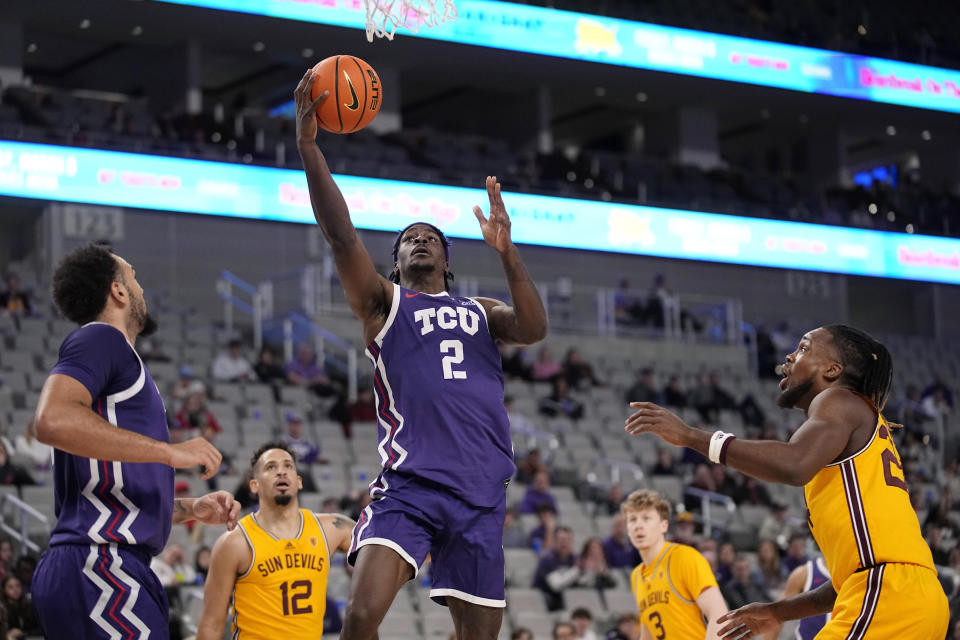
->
[630, 542, 717, 640]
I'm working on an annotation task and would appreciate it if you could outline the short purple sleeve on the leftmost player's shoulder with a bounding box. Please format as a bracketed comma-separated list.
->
[51, 324, 133, 398]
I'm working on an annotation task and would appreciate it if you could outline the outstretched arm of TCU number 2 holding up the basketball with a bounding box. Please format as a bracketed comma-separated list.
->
[294, 69, 393, 337]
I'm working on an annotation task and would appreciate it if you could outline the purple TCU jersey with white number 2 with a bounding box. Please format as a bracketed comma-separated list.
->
[367, 284, 516, 507]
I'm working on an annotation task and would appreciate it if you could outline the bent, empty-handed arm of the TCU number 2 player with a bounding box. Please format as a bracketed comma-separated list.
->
[473, 176, 547, 345]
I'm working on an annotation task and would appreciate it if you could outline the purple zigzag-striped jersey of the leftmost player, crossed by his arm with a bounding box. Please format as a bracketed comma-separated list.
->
[50, 322, 173, 555]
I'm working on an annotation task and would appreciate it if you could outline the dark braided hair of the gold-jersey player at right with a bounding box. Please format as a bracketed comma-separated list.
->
[824, 324, 893, 411]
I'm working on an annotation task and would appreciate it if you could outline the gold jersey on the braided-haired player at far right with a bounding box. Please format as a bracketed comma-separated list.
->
[803, 416, 934, 591]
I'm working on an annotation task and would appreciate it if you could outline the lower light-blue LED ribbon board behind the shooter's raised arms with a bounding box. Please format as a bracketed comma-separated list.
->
[0, 140, 960, 284]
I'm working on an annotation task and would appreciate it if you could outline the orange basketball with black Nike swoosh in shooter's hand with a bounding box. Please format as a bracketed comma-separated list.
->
[311, 56, 383, 133]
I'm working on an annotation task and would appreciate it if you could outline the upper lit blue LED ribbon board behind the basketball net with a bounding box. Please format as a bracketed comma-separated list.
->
[158, 0, 960, 112]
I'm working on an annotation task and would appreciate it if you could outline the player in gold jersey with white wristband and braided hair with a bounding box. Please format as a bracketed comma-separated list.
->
[626, 325, 950, 640]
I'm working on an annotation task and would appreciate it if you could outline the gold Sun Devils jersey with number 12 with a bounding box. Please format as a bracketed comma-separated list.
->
[233, 509, 330, 640]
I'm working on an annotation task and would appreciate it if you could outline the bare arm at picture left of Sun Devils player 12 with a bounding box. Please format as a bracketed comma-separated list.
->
[197, 530, 251, 640]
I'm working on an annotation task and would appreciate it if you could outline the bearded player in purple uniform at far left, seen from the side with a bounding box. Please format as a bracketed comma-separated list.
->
[32, 245, 240, 640]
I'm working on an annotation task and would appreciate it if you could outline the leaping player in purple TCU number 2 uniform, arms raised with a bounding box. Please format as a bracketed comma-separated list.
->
[294, 71, 547, 640]
